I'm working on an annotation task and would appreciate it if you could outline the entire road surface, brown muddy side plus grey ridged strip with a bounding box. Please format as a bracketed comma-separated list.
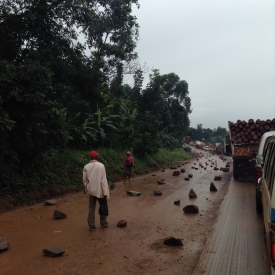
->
[0, 151, 269, 275]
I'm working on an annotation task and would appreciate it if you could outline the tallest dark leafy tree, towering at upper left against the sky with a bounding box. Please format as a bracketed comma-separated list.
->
[0, 0, 138, 168]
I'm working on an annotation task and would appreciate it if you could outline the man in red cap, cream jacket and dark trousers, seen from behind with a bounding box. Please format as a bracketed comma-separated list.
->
[83, 151, 109, 231]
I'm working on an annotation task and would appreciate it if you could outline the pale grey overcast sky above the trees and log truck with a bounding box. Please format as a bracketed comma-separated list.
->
[129, 0, 275, 129]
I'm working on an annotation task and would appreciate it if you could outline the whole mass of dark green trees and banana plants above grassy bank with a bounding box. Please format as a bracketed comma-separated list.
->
[0, 0, 191, 192]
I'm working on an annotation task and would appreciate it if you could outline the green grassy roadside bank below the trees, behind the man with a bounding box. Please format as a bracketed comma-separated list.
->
[3, 148, 194, 208]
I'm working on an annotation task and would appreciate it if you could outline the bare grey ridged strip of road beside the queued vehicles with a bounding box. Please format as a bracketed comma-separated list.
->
[193, 179, 270, 275]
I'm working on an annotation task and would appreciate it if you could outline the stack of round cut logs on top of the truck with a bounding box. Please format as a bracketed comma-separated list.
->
[228, 118, 275, 144]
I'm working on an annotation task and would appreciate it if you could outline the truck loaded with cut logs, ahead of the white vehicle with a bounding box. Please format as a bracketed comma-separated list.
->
[228, 119, 275, 179]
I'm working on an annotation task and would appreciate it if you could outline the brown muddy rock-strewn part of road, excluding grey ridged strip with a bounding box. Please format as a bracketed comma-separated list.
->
[0, 152, 272, 275]
